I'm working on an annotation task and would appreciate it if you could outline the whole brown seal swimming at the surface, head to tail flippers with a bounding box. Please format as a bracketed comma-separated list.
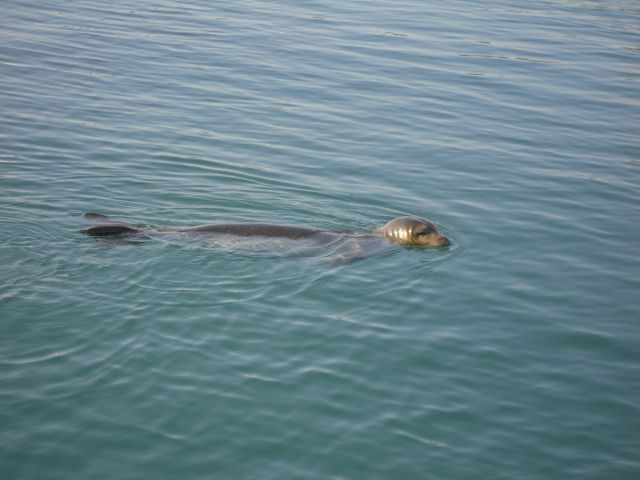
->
[81, 213, 450, 248]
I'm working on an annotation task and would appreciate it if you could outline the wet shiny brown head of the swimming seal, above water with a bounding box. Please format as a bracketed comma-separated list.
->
[374, 217, 451, 247]
